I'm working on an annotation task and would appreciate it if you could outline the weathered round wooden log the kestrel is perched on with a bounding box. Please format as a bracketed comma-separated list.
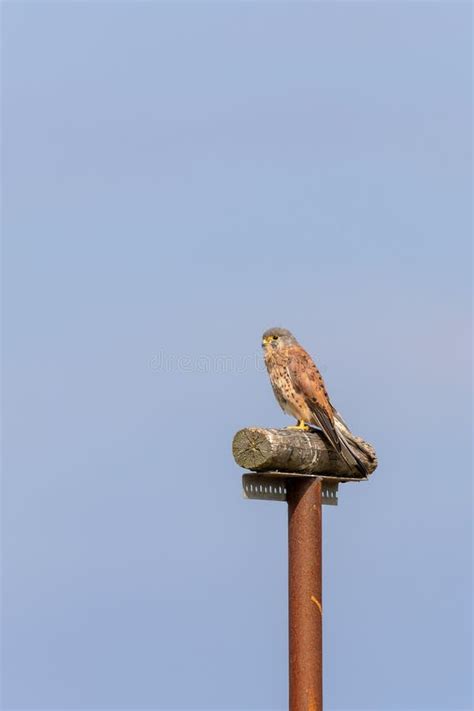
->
[232, 427, 377, 479]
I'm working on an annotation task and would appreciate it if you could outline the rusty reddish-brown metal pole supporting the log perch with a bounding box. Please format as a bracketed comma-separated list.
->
[287, 479, 323, 711]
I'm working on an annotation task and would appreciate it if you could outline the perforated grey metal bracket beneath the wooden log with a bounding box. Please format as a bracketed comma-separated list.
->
[242, 472, 339, 506]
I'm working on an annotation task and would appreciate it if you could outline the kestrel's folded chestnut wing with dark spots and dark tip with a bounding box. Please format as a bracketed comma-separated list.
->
[288, 346, 341, 452]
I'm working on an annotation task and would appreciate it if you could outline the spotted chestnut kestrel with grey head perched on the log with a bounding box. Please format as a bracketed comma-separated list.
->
[262, 328, 367, 476]
